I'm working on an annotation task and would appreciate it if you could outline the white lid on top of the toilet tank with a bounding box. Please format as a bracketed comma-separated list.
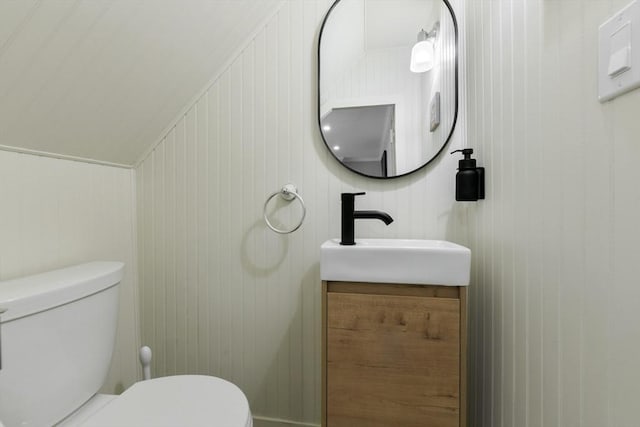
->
[0, 261, 124, 323]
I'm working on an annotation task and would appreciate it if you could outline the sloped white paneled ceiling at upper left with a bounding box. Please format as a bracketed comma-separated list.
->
[0, 0, 279, 165]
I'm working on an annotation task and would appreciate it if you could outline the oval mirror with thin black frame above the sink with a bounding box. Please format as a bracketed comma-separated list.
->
[318, 0, 458, 178]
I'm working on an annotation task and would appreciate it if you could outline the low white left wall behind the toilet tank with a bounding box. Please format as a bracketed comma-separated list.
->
[0, 151, 140, 393]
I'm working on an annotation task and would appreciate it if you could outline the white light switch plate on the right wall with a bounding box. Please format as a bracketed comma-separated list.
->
[598, 0, 640, 102]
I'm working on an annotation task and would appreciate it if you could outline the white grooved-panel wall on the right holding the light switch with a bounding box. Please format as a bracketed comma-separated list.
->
[466, 0, 640, 427]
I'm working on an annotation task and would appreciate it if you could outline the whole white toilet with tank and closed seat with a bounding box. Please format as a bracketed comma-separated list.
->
[0, 262, 252, 427]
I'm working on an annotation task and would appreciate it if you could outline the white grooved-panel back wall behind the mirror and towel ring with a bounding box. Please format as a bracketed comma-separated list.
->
[137, 0, 467, 423]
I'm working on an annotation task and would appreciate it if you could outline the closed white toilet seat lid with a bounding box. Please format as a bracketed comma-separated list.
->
[83, 375, 252, 427]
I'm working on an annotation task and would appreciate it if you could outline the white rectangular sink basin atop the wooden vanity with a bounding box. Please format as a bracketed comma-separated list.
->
[320, 239, 471, 286]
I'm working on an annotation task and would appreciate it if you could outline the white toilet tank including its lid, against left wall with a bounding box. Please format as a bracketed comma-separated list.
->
[0, 262, 124, 427]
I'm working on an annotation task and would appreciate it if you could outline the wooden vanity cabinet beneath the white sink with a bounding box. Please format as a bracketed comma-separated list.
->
[322, 282, 467, 427]
